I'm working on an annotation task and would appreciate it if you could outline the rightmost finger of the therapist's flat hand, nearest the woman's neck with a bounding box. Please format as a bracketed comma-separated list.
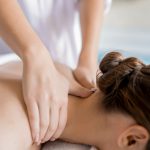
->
[52, 105, 67, 140]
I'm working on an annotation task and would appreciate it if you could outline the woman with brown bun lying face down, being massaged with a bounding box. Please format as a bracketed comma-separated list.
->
[0, 52, 150, 150]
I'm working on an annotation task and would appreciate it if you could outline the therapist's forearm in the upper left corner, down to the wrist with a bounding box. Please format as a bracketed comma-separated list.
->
[0, 0, 54, 65]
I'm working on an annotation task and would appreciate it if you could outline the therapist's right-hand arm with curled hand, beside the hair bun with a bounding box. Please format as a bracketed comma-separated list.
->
[74, 0, 104, 89]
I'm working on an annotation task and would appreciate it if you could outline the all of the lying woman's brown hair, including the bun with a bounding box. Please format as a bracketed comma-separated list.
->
[97, 52, 150, 150]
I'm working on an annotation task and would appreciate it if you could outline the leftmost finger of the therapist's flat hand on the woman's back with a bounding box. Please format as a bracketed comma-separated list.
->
[26, 102, 39, 143]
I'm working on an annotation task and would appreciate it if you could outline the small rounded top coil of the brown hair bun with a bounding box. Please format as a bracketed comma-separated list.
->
[99, 52, 124, 74]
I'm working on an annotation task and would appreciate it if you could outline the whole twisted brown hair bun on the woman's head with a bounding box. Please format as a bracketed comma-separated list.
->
[97, 52, 145, 94]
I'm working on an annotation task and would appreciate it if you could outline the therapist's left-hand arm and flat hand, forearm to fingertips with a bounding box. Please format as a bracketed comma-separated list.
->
[0, 0, 69, 143]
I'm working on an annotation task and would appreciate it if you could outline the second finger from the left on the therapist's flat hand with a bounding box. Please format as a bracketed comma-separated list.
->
[38, 99, 50, 143]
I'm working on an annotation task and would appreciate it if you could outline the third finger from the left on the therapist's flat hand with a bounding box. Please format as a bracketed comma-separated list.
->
[42, 105, 59, 143]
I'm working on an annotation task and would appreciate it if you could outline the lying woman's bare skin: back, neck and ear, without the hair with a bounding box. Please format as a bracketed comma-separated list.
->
[0, 63, 149, 150]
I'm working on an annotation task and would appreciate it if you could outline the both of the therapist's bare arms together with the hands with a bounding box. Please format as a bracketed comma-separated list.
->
[0, 0, 103, 143]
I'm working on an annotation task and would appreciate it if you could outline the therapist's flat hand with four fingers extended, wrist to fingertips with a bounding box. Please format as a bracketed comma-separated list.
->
[23, 51, 69, 144]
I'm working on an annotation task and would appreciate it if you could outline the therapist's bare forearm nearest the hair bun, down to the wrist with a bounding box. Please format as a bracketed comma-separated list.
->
[79, 0, 104, 66]
